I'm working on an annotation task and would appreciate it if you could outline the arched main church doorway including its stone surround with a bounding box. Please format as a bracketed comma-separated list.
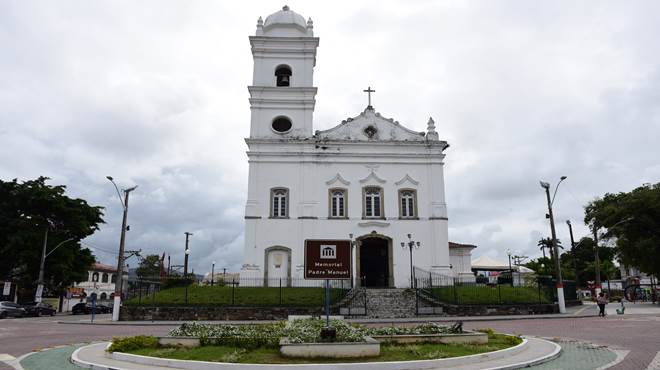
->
[355, 233, 394, 288]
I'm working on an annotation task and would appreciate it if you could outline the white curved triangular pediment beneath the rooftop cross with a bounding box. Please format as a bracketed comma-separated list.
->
[315, 107, 426, 142]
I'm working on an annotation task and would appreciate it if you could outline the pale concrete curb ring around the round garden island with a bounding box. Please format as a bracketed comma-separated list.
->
[71, 338, 561, 370]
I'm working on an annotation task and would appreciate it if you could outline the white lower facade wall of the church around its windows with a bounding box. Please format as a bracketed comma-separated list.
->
[243, 155, 450, 287]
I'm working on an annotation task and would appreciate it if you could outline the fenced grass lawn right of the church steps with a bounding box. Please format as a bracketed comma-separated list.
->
[431, 285, 550, 304]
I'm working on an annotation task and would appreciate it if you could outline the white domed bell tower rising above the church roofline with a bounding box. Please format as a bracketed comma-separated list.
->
[248, 6, 319, 139]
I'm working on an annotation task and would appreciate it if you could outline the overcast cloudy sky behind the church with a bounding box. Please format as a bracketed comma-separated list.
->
[0, 0, 660, 272]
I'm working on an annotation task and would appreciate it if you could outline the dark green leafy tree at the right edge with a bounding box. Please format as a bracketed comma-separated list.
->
[584, 183, 660, 276]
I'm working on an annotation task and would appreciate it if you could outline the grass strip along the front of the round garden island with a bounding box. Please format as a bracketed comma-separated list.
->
[130, 334, 515, 364]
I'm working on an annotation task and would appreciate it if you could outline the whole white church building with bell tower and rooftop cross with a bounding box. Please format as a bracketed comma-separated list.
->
[240, 6, 472, 288]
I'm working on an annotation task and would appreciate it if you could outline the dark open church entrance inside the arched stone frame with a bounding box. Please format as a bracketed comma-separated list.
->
[359, 237, 391, 288]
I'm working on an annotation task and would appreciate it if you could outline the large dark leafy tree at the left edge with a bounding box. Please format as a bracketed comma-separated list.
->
[0, 177, 103, 297]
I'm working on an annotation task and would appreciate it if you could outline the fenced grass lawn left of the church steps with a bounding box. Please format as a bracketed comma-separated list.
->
[125, 285, 344, 306]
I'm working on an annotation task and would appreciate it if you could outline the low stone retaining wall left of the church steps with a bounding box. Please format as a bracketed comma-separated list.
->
[119, 305, 323, 321]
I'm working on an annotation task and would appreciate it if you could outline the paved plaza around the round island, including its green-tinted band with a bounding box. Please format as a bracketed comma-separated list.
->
[0, 304, 660, 370]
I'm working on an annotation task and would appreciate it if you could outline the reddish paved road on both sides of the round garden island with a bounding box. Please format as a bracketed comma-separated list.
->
[0, 306, 660, 370]
